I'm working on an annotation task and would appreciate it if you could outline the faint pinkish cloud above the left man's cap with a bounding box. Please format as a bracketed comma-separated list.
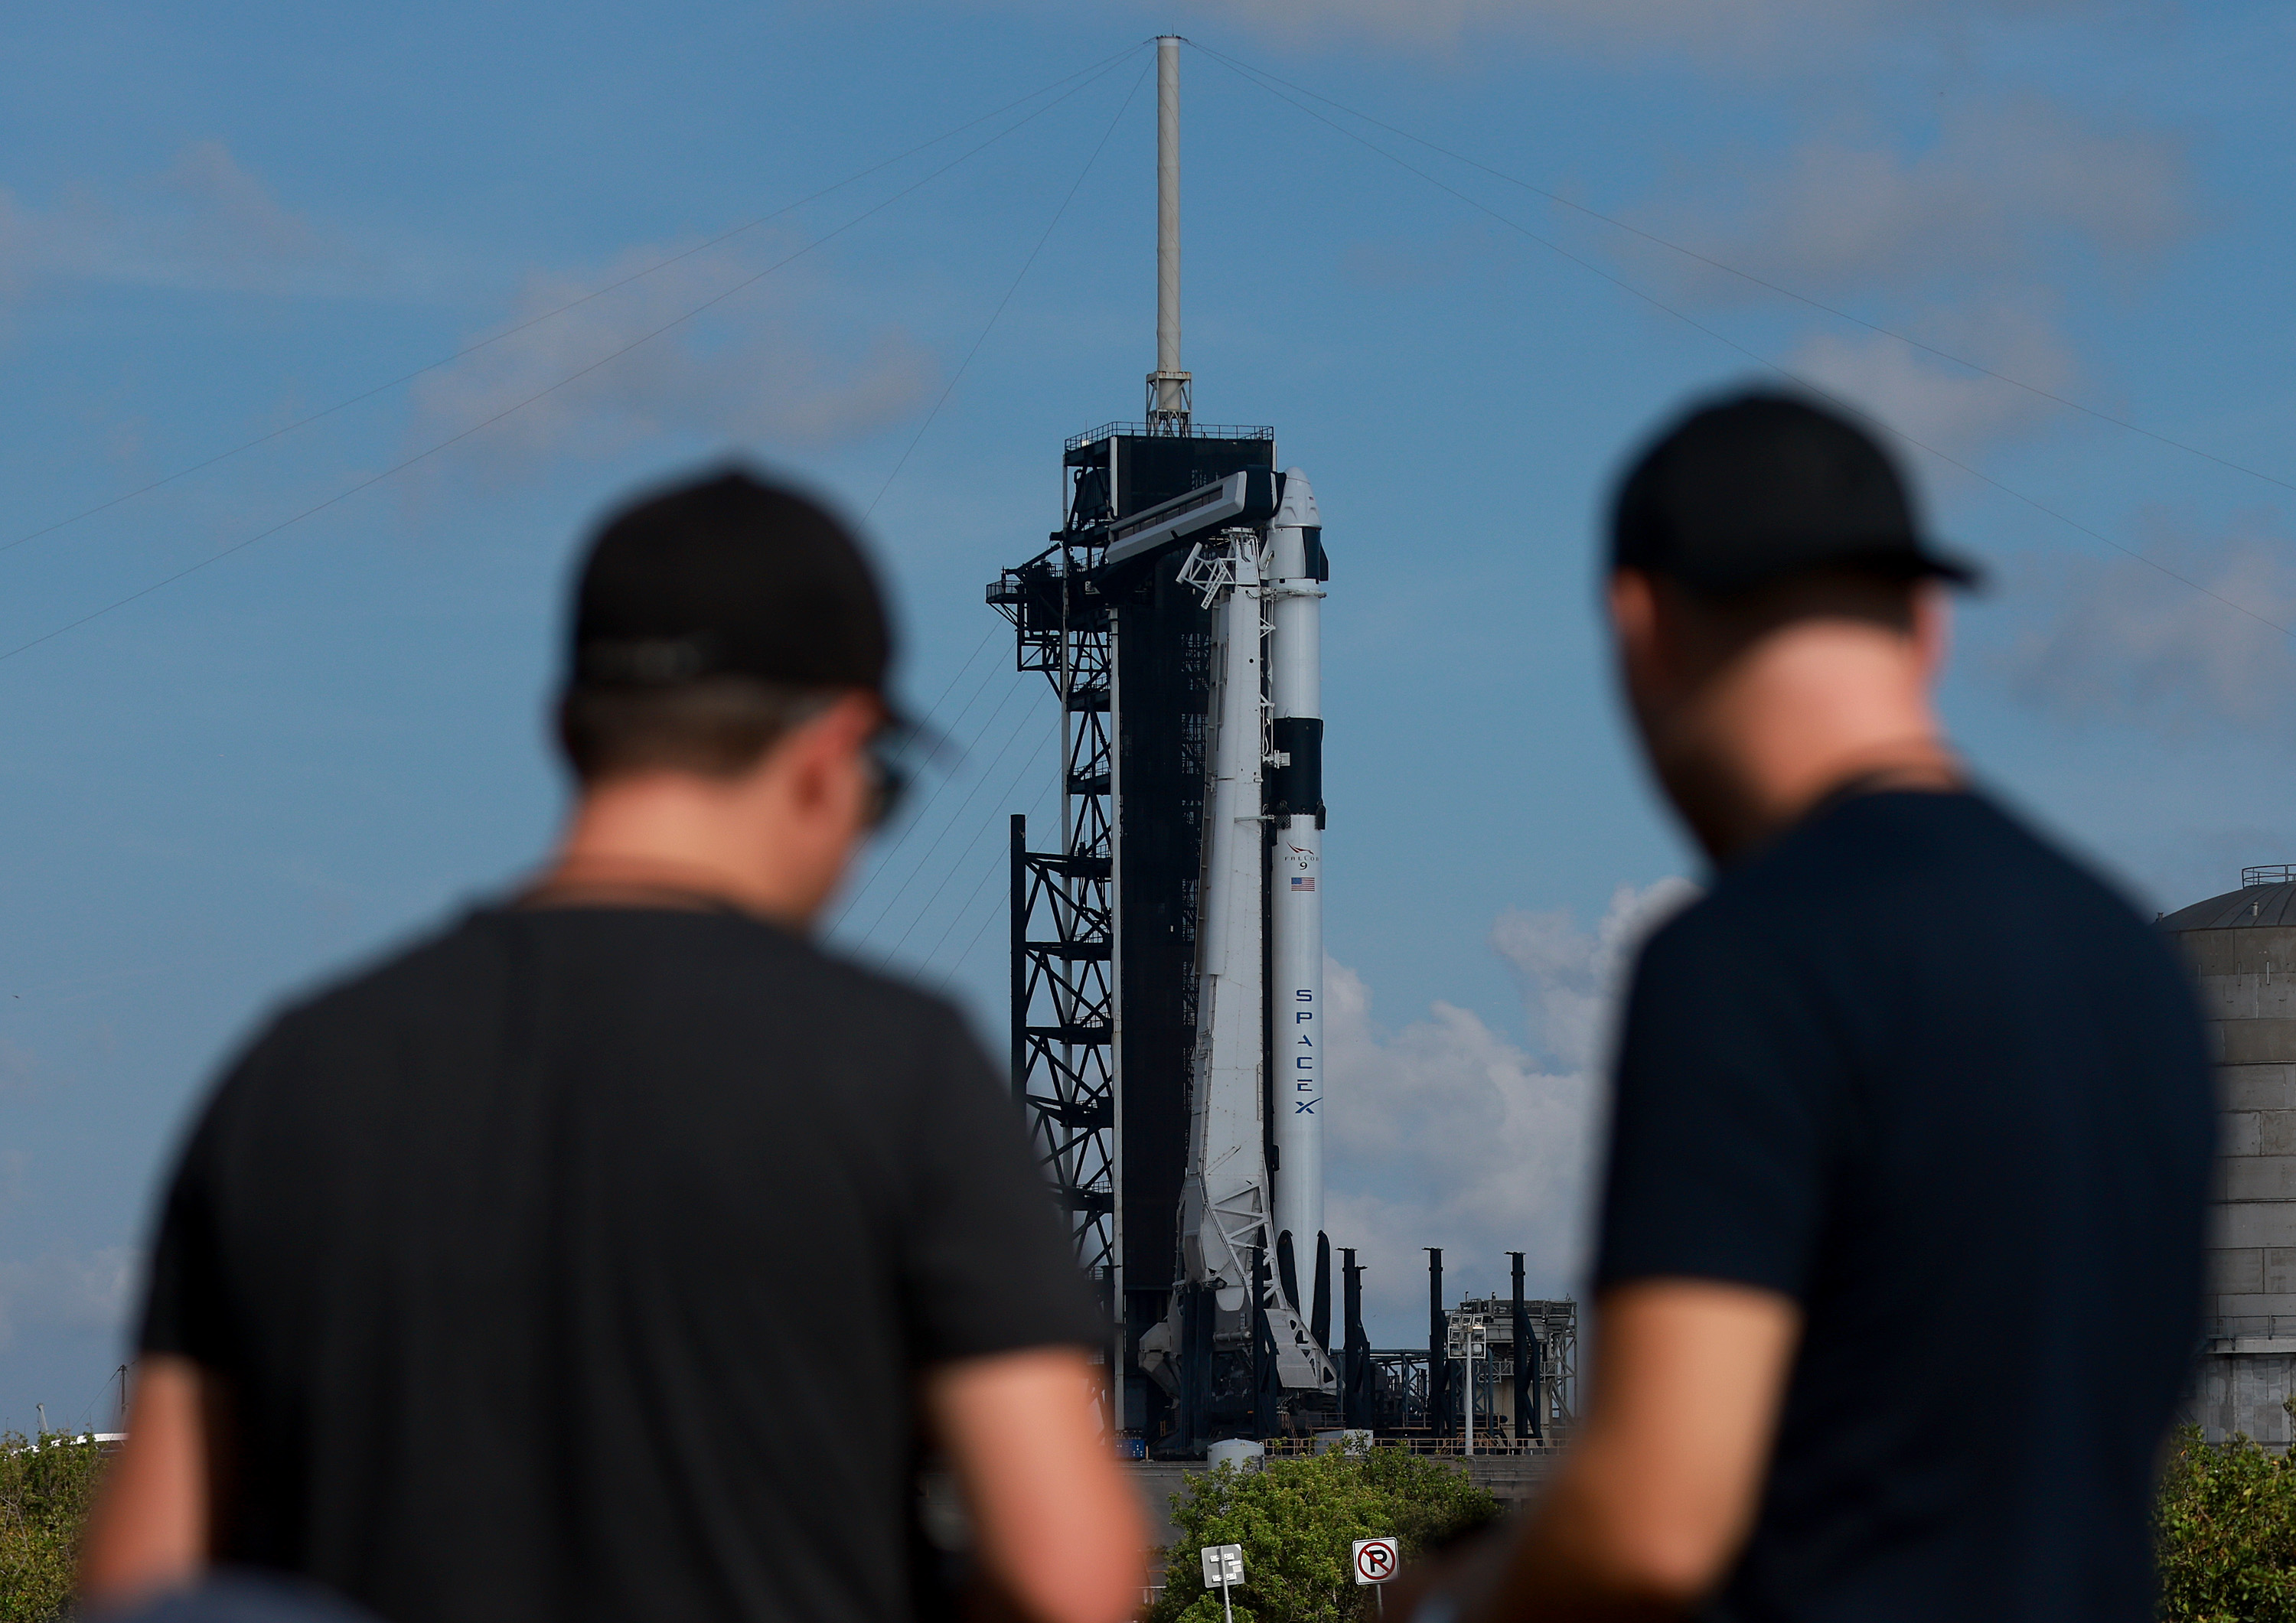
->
[411, 243, 939, 475]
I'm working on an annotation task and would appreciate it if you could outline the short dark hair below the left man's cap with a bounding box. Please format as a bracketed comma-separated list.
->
[558, 677, 838, 790]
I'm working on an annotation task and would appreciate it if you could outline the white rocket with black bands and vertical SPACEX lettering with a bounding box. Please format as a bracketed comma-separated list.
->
[1265, 468, 1332, 1348]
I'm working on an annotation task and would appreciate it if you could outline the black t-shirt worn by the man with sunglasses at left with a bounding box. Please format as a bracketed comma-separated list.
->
[142, 909, 1100, 1623]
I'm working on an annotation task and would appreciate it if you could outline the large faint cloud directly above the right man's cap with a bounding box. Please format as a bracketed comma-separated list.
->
[1637, 96, 2193, 459]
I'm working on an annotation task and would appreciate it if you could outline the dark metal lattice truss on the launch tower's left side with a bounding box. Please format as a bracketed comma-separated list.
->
[990, 530, 1116, 1283]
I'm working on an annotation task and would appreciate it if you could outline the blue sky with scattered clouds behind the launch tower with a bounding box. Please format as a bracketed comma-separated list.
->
[0, 0, 2296, 1426]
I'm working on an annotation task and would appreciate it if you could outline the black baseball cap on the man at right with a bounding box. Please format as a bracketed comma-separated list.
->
[1609, 393, 1979, 592]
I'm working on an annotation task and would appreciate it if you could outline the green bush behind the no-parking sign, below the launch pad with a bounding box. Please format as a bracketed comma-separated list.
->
[1146, 1449, 1499, 1623]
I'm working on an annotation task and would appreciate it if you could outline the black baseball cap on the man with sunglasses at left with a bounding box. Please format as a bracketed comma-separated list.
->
[567, 468, 893, 696]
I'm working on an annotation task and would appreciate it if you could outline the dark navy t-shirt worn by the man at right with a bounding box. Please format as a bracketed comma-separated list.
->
[1596, 794, 2213, 1623]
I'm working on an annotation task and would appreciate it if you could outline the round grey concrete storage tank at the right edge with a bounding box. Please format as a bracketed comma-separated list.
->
[2161, 868, 2296, 1444]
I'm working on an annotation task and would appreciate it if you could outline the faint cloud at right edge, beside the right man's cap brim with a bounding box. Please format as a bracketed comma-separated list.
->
[1993, 512, 2296, 744]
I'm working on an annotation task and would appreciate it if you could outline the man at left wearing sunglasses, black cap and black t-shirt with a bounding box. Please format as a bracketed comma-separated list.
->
[87, 473, 1143, 1623]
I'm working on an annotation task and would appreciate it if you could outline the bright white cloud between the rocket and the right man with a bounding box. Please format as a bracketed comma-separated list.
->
[1325, 879, 1694, 1338]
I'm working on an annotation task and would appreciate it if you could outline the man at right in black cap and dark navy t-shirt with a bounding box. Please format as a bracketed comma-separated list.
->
[1419, 395, 2211, 1623]
